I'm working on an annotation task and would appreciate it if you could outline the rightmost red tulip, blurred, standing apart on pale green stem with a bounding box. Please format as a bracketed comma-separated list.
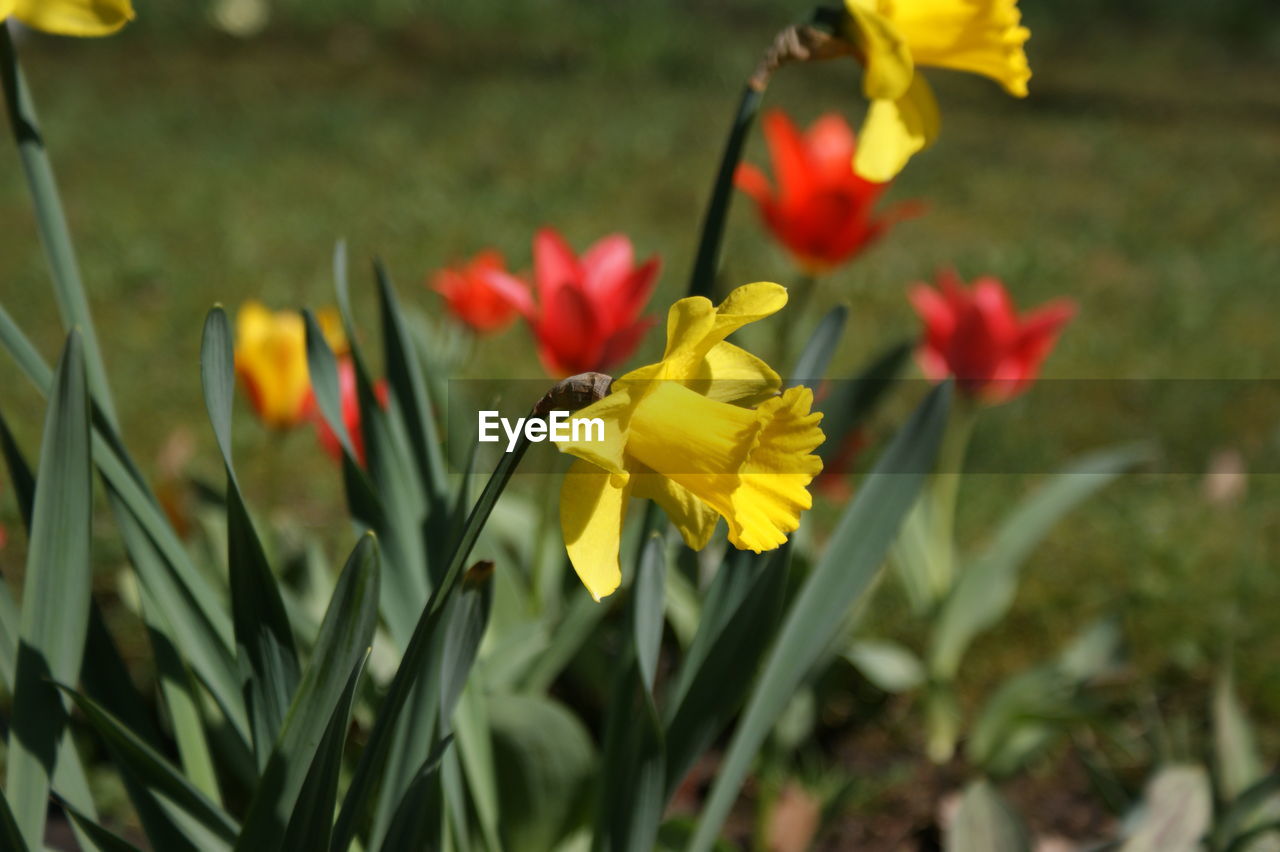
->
[910, 271, 1075, 402]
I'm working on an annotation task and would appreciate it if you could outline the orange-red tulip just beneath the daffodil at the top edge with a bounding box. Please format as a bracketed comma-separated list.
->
[733, 110, 920, 275]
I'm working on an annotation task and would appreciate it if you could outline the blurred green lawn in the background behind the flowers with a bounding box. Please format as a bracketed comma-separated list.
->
[0, 3, 1280, 736]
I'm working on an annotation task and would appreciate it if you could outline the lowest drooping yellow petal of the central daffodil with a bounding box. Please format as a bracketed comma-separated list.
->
[561, 461, 628, 600]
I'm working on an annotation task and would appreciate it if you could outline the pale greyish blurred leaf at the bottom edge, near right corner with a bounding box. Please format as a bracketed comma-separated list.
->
[1120, 766, 1213, 852]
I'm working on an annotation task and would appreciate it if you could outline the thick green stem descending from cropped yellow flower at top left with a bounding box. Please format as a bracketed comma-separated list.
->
[0, 27, 119, 431]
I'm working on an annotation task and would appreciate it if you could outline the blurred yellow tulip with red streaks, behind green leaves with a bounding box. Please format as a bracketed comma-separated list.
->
[236, 299, 347, 429]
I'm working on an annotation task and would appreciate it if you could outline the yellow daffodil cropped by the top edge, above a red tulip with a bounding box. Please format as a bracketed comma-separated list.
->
[845, 0, 1032, 182]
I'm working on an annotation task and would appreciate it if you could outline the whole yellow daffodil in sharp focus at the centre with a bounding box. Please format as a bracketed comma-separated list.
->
[557, 283, 823, 600]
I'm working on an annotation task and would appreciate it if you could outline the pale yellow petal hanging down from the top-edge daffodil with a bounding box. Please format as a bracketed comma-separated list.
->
[854, 74, 941, 183]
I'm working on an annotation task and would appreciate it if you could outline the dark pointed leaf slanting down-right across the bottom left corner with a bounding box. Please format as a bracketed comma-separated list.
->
[60, 686, 239, 847]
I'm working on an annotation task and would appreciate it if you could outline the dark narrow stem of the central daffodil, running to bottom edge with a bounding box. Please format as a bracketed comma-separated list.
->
[330, 440, 529, 851]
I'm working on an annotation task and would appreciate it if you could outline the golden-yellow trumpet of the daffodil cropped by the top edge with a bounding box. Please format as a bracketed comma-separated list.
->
[882, 0, 1032, 97]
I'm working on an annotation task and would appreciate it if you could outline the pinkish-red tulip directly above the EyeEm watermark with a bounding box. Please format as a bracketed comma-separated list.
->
[486, 228, 659, 376]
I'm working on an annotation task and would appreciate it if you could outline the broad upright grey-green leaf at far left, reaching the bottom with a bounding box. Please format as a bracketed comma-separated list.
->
[5, 330, 93, 848]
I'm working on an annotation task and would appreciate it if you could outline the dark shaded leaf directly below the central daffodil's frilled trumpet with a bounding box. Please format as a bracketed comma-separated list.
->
[666, 544, 791, 797]
